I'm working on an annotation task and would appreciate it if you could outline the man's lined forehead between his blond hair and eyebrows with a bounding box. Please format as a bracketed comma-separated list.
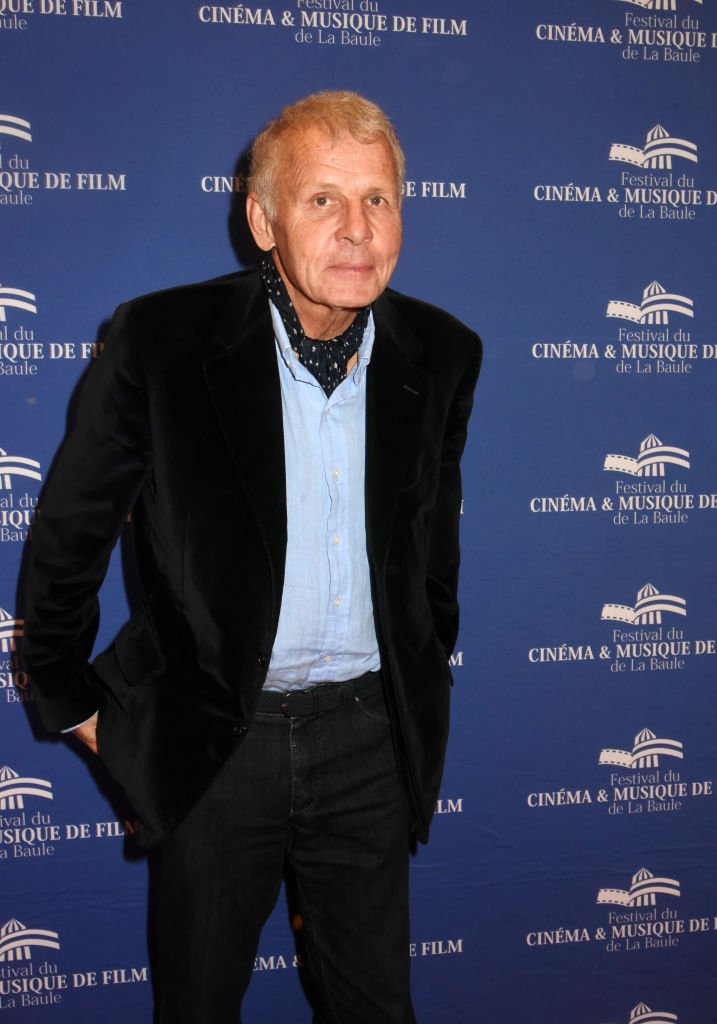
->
[279, 128, 396, 198]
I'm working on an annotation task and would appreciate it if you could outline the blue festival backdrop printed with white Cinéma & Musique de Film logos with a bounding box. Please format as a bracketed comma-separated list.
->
[0, 0, 717, 1024]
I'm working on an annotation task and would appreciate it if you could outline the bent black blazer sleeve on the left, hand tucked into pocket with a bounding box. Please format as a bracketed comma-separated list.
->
[23, 305, 151, 730]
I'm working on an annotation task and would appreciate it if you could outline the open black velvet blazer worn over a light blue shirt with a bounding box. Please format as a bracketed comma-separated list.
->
[24, 272, 480, 844]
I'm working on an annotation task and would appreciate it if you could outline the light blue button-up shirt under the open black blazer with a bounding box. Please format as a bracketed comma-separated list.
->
[264, 303, 381, 690]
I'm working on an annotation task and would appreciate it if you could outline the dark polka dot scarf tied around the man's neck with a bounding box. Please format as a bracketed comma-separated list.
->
[259, 253, 369, 397]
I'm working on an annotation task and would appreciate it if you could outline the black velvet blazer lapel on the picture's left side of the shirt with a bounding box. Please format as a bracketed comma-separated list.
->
[204, 274, 287, 580]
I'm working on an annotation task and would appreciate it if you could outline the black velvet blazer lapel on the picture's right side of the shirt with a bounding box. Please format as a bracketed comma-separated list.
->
[366, 293, 430, 564]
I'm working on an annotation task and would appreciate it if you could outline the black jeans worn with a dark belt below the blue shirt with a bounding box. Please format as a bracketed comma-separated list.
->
[153, 673, 415, 1024]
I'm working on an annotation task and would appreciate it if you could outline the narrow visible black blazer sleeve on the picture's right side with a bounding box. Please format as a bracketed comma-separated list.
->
[426, 332, 482, 658]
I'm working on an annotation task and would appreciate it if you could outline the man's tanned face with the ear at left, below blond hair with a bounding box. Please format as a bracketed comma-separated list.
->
[247, 129, 400, 338]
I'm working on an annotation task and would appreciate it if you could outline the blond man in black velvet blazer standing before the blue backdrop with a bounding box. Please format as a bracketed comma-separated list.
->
[25, 92, 480, 1024]
